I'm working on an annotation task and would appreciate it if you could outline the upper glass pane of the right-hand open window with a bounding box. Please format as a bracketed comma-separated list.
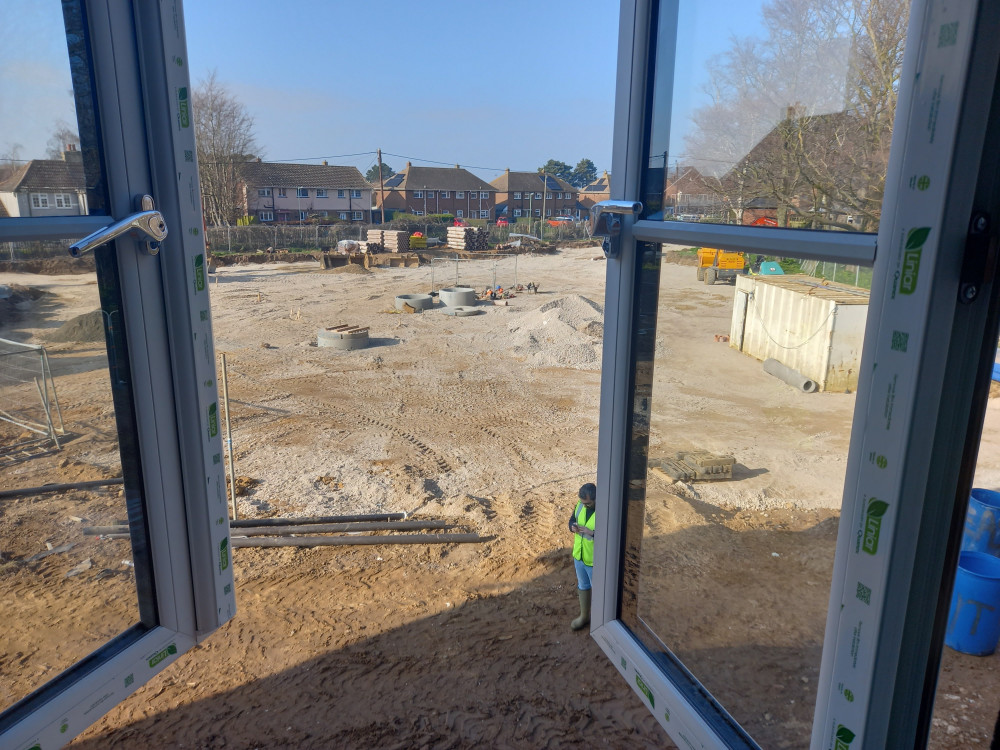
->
[643, 0, 909, 232]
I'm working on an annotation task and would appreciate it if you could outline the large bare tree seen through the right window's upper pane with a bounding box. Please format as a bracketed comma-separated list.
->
[687, 0, 908, 229]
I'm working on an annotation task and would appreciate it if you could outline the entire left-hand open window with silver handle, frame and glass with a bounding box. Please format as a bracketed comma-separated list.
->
[0, 0, 235, 748]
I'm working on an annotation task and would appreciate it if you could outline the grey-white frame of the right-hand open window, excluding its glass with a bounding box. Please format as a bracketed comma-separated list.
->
[591, 0, 1000, 750]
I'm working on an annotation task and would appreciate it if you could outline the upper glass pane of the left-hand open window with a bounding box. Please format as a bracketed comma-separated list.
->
[0, 0, 107, 219]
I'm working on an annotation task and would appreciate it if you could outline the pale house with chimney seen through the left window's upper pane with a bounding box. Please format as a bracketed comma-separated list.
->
[0, 147, 88, 217]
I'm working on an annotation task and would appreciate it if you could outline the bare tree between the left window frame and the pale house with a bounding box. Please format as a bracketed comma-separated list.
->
[191, 70, 260, 226]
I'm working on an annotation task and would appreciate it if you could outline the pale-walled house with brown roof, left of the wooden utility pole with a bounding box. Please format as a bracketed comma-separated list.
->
[243, 160, 372, 224]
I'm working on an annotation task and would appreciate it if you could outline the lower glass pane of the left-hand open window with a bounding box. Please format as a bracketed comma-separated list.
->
[0, 243, 156, 710]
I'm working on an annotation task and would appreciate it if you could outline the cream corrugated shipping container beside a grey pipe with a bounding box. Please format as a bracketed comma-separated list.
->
[729, 275, 869, 391]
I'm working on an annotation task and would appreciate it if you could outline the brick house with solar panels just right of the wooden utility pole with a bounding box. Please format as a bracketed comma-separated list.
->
[375, 162, 496, 220]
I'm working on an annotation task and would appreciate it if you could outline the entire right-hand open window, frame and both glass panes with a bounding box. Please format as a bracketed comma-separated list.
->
[593, 0, 998, 748]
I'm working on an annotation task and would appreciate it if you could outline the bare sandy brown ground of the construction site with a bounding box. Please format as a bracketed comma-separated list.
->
[0, 247, 1000, 750]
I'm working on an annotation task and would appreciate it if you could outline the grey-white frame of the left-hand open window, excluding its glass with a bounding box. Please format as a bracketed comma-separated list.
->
[0, 0, 235, 748]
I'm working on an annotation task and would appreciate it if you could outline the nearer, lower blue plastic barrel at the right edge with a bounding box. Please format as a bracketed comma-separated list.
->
[944, 552, 1000, 656]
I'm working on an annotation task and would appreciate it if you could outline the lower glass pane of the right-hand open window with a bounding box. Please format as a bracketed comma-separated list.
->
[622, 244, 871, 748]
